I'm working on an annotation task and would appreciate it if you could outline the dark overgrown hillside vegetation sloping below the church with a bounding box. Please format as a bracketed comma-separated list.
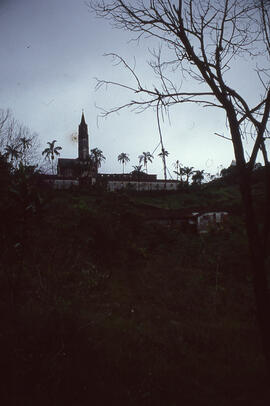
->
[0, 163, 269, 406]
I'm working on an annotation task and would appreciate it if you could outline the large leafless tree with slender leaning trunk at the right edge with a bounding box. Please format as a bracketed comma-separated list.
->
[89, 0, 270, 370]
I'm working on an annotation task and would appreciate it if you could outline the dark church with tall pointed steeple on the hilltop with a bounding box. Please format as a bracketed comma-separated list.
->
[57, 112, 97, 184]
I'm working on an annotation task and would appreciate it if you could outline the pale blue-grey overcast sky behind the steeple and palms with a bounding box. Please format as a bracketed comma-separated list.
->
[0, 0, 264, 178]
